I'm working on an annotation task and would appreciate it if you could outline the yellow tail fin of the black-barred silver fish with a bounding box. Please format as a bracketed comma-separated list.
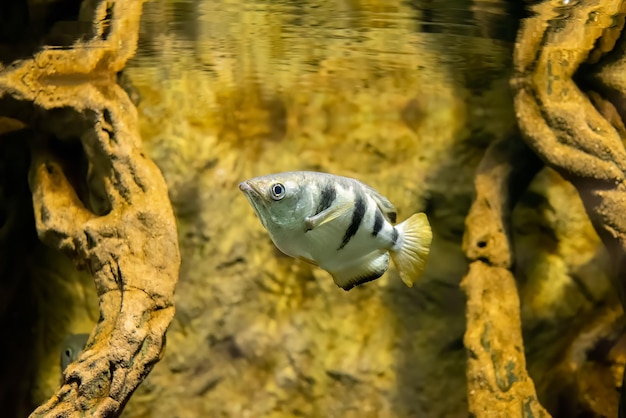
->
[390, 213, 433, 287]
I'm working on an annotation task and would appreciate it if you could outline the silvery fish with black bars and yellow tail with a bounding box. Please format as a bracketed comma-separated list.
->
[239, 171, 432, 291]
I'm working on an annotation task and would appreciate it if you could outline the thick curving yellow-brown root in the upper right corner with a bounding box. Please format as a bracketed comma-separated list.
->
[513, 0, 626, 304]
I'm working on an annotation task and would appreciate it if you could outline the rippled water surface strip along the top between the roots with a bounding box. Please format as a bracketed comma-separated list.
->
[131, 1, 517, 94]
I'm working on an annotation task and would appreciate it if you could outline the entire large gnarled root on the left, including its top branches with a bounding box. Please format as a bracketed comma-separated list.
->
[0, 1, 180, 417]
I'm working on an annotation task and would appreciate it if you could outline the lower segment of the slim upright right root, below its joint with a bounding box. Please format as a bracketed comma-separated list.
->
[462, 261, 550, 418]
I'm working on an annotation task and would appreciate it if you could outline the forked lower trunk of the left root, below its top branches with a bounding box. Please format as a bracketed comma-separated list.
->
[30, 87, 180, 417]
